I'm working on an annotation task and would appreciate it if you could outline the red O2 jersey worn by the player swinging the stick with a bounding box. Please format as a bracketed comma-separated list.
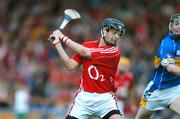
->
[72, 40, 120, 93]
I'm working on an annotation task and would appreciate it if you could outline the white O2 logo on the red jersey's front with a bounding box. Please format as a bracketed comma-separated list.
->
[88, 65, 105, 81]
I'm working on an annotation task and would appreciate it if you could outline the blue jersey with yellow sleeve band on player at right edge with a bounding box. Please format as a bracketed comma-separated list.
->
[152, 32, 180, 89]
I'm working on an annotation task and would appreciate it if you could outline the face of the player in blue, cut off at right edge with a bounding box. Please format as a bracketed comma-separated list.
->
[172, 19, 180, 36]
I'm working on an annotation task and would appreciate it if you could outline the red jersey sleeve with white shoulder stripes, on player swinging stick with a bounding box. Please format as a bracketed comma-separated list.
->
[91, 47, 119, 58]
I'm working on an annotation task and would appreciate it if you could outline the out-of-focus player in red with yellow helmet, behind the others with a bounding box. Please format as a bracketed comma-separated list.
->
[115, 57, 137, 119]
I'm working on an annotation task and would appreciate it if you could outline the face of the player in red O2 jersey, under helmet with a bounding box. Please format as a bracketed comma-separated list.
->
[105, 29, 122, 46]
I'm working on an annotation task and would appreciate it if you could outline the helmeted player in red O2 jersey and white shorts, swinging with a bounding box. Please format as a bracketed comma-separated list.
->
[50, 18, 125, 119]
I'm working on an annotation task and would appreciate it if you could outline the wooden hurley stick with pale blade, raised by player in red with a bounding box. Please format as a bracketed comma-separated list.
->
[48, 9, 81, 42]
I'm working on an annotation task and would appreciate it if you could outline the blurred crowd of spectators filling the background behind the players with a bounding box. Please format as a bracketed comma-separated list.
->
[0, 0, 180, 119]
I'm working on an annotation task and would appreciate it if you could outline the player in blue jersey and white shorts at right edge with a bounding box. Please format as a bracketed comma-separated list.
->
[136, 13, 180, 119]
